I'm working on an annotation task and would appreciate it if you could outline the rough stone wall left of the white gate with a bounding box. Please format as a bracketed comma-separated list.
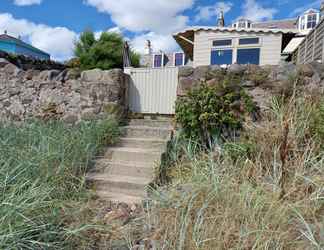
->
[0, 59, 127, 123]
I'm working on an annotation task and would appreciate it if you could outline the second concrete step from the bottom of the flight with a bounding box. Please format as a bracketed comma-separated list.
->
[87, 173, 151, 197]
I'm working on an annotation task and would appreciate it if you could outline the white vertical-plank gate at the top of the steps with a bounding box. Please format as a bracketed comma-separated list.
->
[125, 67, 178, 114]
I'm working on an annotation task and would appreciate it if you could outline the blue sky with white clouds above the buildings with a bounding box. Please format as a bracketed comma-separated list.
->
[0, 0, 321, 61]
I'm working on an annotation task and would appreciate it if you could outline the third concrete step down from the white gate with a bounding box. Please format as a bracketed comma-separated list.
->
[117, 137, 167, 151]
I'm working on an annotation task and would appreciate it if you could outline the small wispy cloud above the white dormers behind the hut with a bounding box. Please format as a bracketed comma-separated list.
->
[242, 0, 278, 21]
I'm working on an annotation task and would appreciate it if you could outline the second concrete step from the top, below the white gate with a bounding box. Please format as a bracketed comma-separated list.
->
[122, 126, 171, 140]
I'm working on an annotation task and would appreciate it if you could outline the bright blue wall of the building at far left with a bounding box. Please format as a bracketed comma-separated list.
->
[0, 41, 50, 60]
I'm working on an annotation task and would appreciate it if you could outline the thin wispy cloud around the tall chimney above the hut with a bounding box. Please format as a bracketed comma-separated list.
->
[195, 2, 233, 23]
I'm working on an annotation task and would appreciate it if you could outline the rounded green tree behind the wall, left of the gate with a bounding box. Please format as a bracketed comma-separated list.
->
[74, 31, 140, 70]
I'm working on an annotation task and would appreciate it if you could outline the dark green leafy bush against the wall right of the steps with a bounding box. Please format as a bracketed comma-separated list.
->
[176, 76, 256, 145]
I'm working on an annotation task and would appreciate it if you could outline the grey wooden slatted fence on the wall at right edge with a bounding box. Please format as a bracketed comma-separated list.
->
[297, 19, 324, 64]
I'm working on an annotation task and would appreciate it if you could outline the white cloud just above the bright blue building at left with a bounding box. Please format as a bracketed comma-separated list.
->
[0, 13, 78, 61]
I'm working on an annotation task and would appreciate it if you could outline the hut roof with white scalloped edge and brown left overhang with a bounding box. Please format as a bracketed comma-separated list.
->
[173, 26, 298, 60]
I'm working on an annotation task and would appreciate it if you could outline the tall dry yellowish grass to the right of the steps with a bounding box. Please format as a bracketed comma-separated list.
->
[147, 93, 324, 250]
